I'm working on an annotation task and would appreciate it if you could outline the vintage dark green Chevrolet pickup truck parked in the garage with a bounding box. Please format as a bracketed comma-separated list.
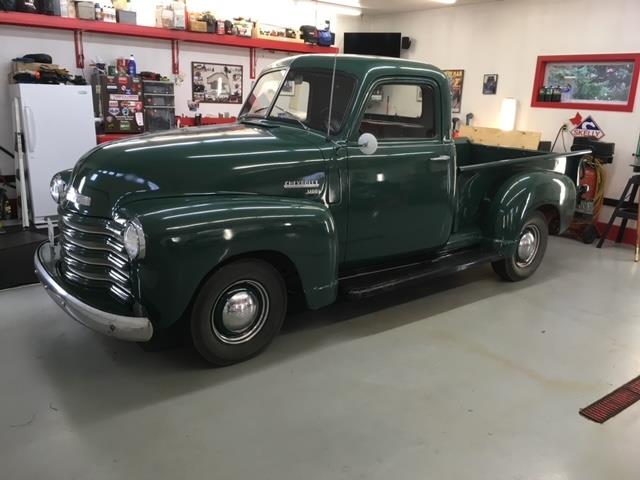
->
[35, 55, 582, 365]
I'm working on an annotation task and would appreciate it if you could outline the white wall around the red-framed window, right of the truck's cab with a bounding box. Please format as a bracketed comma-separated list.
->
[350, 0, 640, 218]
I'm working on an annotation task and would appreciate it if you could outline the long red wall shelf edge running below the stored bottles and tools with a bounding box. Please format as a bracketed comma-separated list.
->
[0, 12, 338, 53]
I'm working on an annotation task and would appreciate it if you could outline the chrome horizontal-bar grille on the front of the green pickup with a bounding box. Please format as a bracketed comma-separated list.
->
[58, 214, 133, 302]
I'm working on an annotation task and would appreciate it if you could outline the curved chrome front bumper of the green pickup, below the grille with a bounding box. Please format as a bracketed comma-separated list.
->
[34, 242, 153, 342]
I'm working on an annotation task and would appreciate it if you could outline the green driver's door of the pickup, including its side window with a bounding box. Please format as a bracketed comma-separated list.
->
[345, 80, 455, 265]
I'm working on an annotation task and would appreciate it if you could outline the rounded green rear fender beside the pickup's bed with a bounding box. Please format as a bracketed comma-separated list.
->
[484, 170, 576, 256]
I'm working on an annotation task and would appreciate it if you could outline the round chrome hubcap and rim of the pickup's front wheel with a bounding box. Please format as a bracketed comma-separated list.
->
[211, 280, 269, 345]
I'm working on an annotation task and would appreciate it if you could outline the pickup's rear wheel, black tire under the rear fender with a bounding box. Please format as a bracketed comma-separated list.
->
[491, 212, 549, 282]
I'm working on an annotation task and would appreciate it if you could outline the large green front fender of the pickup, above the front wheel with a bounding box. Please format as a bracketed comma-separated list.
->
[122, 195, 338, 328]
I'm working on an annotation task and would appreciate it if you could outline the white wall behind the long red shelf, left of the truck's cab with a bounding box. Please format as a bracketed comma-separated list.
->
[0, 0, 342, 175]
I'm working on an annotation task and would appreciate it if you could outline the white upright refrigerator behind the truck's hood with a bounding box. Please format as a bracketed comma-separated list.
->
[10, 84, 96, 227]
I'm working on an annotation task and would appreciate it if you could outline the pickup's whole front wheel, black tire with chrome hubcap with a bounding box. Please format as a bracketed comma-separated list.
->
[191, 259, 287, 366]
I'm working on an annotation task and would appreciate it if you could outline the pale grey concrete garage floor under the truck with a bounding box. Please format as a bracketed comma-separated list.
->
[0, 239, 640, 480]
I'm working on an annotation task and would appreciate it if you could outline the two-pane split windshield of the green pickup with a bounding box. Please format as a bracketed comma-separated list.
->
[240, 69, 356, 134]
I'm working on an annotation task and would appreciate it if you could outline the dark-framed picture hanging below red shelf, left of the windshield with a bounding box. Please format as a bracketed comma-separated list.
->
[191, 62, 243, 103]
